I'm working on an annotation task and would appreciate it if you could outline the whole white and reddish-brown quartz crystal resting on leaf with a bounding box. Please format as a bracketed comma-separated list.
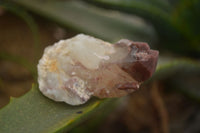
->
[37, 34, 158, 105]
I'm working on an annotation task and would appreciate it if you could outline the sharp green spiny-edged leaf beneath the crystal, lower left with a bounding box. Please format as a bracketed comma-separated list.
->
[0, 85, 114, 133]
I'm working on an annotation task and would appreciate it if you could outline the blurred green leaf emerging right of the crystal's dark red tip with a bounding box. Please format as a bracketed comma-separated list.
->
[147, 58, 200, 103]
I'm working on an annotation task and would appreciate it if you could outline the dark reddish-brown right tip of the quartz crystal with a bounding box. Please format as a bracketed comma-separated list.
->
[116, 39, 159, 82]
